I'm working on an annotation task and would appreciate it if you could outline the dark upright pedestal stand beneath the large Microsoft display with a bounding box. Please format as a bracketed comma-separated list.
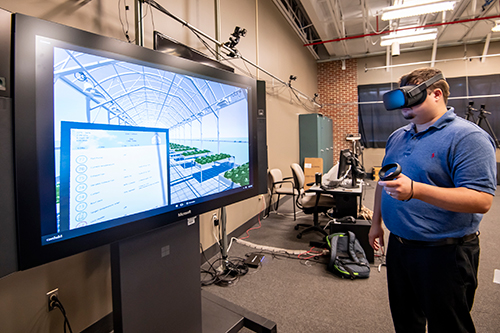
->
[111, 218, 202, 333]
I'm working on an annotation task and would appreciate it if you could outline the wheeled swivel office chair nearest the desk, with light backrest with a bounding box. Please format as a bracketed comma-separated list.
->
[290, 163, 335, 239]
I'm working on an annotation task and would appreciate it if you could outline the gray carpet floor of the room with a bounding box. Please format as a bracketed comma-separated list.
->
[203, 181, 500, 333]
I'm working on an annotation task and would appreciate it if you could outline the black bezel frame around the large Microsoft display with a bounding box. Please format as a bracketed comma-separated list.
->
[13, 14, 259, 269]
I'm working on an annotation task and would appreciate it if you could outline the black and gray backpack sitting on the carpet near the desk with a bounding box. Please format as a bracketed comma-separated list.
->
[326, 231, 370, 279]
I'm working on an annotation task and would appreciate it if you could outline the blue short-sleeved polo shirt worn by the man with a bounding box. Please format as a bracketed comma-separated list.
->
[381, 108, 496, 241]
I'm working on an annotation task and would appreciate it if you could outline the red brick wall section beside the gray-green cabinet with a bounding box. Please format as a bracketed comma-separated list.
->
[318, 59, 358, 163]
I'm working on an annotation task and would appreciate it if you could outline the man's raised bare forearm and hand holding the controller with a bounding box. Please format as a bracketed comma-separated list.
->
[379, 174, 493, 214]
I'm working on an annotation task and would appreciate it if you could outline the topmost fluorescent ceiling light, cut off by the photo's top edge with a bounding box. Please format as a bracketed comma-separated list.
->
[382, 0, 456, 21]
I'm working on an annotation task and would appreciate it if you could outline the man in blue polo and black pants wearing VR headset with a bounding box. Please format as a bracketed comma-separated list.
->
[369, 68, 496, 333]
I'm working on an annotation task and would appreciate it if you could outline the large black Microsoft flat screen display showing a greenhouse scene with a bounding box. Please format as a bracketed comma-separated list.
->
[14, 15, 258, 268]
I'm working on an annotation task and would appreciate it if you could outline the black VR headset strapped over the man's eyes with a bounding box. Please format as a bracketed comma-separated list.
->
[382, 73, 444, 111]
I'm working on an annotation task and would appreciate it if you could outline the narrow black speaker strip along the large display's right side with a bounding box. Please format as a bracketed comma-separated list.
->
[257, 80, 267, 194]
